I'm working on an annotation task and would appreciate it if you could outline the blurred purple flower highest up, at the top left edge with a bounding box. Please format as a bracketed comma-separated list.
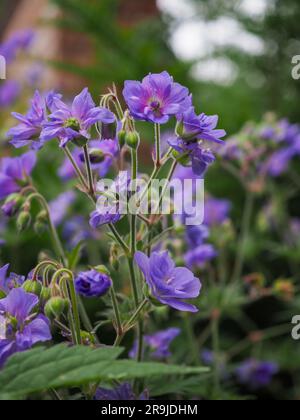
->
[0, 29, 34, 64]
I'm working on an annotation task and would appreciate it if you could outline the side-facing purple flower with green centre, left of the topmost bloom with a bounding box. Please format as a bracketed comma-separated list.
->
[41, 88, 115, 147]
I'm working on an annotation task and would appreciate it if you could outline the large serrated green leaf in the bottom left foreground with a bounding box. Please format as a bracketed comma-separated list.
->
[0, 345, 208, 400]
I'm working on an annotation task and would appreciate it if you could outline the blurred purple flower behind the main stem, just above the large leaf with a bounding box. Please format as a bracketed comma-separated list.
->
[129, 328, 181, 359]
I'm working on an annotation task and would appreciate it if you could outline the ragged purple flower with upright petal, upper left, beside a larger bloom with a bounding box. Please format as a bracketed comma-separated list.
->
[7, 90, 47, 149]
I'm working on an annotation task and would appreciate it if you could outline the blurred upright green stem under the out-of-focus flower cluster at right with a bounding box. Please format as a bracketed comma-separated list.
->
[232, 191, 254, 282]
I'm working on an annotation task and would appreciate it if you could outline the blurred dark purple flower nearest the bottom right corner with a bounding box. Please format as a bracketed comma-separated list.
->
[236, 359, 279, 389]
